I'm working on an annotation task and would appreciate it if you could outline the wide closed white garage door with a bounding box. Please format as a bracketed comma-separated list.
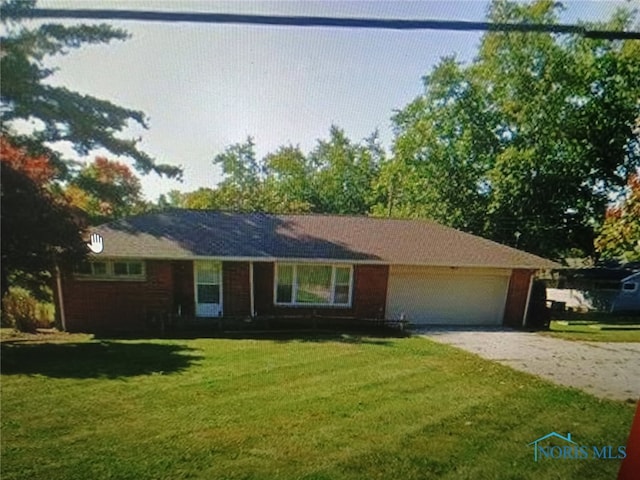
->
[386, 266, 510, 325]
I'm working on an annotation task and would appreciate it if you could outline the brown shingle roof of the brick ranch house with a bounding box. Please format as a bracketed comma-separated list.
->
[93, 210, 557, 269]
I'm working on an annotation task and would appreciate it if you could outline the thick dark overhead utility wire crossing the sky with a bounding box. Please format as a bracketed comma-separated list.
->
[26, 8, 640, 40]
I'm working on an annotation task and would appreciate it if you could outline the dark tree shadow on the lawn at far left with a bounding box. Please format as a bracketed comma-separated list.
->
[1, 340, 202, 379]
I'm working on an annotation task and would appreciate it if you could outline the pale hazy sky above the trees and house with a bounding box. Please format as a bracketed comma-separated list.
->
[28, 0, 640, 200]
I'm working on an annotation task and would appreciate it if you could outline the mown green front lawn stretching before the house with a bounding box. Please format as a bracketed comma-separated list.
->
[1, 334, 633, 480]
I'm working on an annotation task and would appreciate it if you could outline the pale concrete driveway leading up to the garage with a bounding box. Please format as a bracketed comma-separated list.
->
[418, 328, 640, 401]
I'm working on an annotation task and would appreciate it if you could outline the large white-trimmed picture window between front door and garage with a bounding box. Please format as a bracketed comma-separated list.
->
[274, 263, 353, 307]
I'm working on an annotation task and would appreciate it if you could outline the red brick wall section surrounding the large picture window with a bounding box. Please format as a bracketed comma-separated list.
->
[252, 262, 389, 318]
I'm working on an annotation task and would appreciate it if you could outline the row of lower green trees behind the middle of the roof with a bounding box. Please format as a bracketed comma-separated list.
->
[170, 126, 385, 214]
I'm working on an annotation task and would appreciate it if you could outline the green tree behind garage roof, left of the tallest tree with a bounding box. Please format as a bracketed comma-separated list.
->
[373, 57, 500, 233]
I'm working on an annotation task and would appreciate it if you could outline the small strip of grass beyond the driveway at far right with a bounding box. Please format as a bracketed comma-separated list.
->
[542, 317, 640, 342]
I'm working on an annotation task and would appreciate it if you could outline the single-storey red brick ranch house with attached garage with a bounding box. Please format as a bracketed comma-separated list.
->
[58, 210, 558, 331]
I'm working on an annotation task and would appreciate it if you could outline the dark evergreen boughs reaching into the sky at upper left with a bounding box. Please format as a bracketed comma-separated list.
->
[0, 0, 181, 177]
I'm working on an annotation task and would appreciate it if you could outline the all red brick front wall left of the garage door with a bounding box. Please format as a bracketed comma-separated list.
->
[62, 260, 389, 332]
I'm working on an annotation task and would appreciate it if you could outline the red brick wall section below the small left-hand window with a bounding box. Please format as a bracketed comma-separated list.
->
[62, 260, 174, 332]
